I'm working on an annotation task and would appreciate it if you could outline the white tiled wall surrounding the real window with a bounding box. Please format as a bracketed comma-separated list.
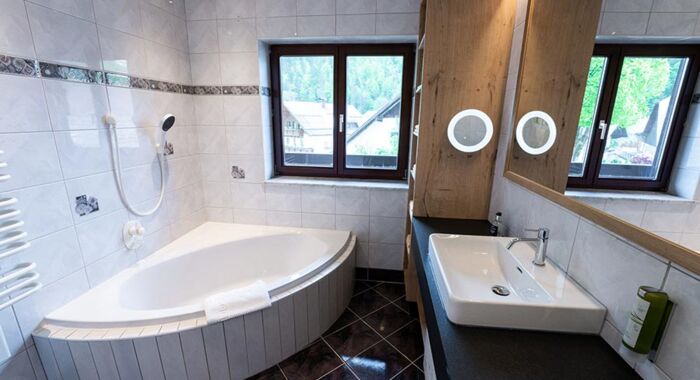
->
[186, 0, 420, 270]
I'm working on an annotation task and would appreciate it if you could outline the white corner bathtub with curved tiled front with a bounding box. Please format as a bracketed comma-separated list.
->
[33, 222, 355, 379]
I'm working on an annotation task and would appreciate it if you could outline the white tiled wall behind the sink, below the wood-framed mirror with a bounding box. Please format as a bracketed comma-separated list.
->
[491, 0, 700, 380]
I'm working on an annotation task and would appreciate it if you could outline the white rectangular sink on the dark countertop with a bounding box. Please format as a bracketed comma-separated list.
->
[429, 234, 606, 334]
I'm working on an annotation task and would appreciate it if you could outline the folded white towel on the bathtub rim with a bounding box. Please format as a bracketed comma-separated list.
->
[204, 280, 272, 323]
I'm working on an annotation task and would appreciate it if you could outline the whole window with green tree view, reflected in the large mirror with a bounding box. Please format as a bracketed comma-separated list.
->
[569, 45, 700, 191]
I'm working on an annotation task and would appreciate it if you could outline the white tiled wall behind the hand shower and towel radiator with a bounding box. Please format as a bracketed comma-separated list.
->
[0, 0, 205, 379]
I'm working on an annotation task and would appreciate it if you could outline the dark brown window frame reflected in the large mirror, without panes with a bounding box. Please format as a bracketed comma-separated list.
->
[567, 44, 700, 192]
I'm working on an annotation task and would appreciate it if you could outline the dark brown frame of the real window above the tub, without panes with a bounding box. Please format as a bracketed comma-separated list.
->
[270, 43, 415, 180]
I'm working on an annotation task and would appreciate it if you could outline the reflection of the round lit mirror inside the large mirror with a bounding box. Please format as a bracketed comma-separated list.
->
[515, 111, 557, 155]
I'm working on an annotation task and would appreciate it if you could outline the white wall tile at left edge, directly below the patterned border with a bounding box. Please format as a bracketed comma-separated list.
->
[0, 75, 51, 133]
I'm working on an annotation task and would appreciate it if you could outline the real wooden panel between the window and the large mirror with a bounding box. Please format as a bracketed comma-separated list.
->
[413, 0, 516, 218]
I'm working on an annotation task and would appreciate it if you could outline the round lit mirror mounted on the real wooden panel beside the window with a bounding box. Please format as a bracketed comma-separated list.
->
[447, 109, 493, 153]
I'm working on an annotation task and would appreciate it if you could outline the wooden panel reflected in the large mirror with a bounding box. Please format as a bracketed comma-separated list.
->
[508, 0, 602, 192]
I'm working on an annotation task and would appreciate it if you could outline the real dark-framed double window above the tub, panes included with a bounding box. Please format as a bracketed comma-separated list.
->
[271, 44, 414, 179]
